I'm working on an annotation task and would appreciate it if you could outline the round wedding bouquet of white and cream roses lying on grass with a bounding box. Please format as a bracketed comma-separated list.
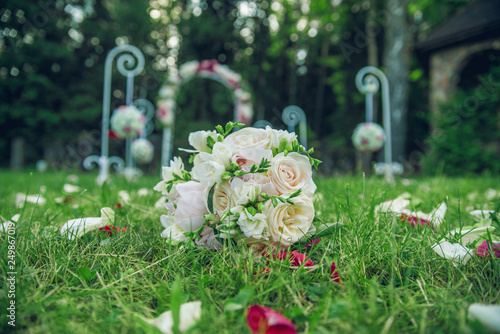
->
[154, 122, 321, 249]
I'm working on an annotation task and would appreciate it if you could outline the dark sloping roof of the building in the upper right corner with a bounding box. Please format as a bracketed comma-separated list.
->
[416, 0, 500, 52]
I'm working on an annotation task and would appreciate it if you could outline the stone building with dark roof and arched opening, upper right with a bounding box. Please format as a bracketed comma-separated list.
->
[416, 0, 500, 118]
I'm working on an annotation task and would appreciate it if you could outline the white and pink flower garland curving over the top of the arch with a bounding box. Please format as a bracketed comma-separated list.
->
[156, 59, 253, 127]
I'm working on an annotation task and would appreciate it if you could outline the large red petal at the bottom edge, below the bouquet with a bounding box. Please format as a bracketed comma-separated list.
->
[247, 305, 297, 334]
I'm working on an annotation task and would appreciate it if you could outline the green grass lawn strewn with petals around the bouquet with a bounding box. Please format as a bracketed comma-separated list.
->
[0, 171, 500, 334]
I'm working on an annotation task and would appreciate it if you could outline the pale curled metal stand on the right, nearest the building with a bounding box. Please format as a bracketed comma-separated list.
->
[356, 66, 394, 182]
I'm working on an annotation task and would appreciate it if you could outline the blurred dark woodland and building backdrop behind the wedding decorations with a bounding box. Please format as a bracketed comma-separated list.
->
[0, 0, 500, 175]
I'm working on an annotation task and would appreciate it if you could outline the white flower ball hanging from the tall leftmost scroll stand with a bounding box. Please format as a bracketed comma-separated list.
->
[111, 106, 146, 139]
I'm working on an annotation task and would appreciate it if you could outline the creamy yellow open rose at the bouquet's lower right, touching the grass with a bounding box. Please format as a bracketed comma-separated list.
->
[263, 195, 314, 247]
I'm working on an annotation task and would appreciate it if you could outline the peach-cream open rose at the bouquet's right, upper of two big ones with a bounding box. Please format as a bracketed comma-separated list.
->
[268, 152, 316, 196]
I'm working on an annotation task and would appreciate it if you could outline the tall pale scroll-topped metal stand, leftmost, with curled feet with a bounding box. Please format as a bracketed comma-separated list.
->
[83, 45, 144, 185]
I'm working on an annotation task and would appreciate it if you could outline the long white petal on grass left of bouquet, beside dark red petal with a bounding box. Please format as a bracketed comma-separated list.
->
[61, 208, 115, 240]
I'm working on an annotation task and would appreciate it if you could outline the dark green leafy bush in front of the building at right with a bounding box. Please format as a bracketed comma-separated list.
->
[425, 66, 500, 175]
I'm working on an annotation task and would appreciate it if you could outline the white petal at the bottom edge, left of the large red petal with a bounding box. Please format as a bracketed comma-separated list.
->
[144, 301, 201, 334]
